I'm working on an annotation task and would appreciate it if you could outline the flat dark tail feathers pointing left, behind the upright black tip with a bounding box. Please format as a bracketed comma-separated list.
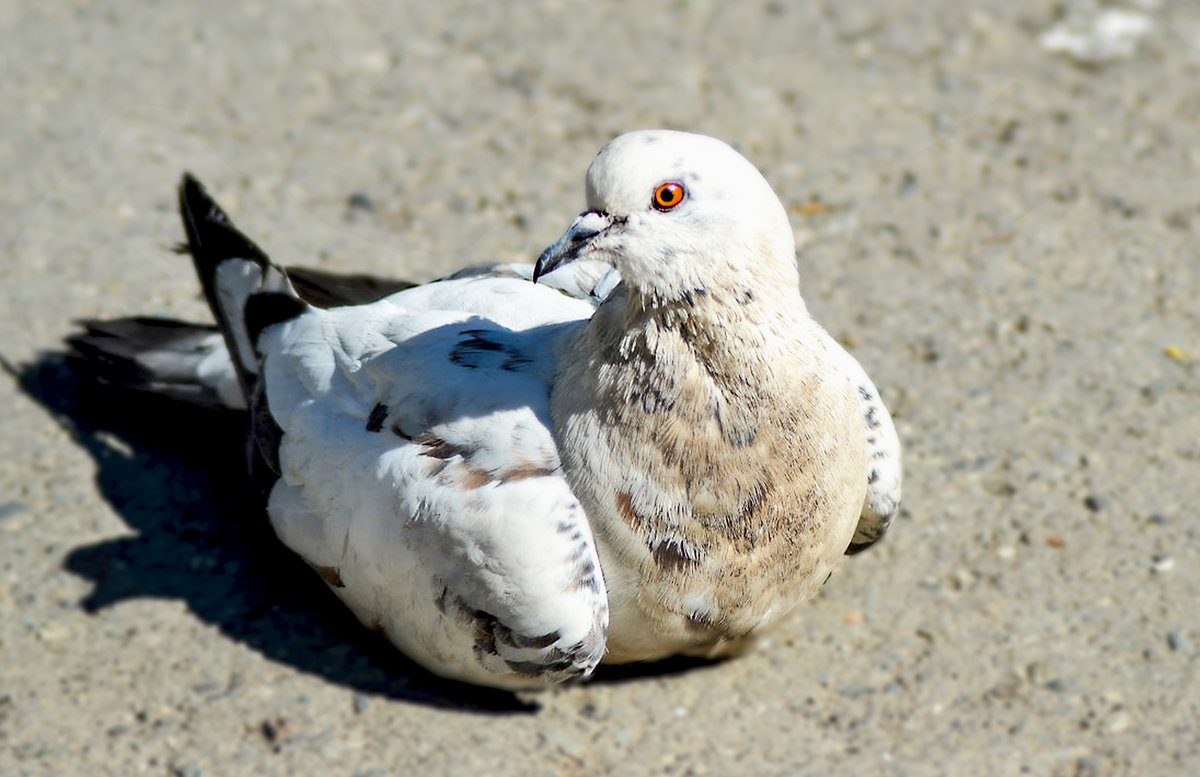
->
[67, 318, 236, 408]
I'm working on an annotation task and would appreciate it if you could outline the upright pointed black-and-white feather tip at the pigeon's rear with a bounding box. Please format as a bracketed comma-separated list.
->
[179, 173, 305, 399]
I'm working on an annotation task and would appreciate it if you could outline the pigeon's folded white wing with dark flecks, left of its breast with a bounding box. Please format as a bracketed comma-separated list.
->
[259, 276, 607, 687]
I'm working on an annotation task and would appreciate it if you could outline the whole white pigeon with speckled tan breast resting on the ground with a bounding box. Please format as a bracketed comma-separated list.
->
[71, 131, 900, 688]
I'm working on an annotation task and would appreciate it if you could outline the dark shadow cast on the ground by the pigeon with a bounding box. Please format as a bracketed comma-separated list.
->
[11, 354, 718, 715]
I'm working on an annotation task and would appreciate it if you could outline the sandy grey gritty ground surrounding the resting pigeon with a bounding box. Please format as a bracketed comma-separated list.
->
[0, 0, 1200, 777]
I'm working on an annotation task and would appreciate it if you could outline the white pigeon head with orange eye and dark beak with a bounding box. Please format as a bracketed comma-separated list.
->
[534, 130, 799, 303]
